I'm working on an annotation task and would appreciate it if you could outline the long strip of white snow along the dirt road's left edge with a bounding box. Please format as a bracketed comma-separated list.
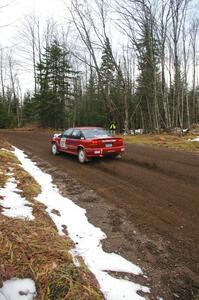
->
[14, 148, 149, 300]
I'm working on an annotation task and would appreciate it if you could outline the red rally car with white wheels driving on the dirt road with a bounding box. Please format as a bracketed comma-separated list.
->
[51, 127, 125, 163]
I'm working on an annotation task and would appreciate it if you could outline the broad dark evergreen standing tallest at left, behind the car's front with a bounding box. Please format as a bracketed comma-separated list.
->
[36, 40, 75, 128]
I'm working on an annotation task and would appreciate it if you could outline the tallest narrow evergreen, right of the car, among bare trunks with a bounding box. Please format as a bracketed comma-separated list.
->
[136, 4, 160, 131]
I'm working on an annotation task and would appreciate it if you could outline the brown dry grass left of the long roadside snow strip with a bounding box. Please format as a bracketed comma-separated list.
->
[0, 144, 104, 300]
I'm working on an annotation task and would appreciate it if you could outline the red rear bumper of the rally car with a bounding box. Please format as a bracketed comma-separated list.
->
[86, 146, 125, 157]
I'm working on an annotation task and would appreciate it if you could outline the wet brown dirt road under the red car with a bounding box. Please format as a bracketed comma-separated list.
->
[0, 130, 199, 300]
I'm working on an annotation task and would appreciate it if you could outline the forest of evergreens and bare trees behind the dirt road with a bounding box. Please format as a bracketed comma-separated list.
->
[0, 0, 199, 133]
